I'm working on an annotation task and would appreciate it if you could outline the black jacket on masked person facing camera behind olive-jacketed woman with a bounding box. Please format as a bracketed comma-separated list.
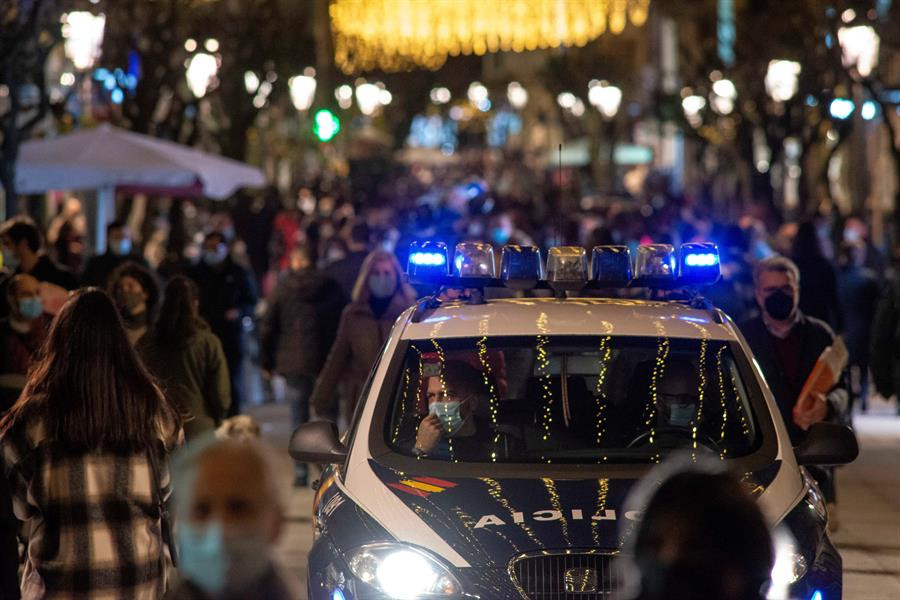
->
[188, 256, 258, 360]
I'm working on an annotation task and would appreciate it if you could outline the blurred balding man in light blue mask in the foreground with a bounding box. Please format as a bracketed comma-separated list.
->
[169, 436, 300, 600]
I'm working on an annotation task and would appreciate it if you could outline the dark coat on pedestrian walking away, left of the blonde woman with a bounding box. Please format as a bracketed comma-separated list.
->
[260, 269, 343, 377]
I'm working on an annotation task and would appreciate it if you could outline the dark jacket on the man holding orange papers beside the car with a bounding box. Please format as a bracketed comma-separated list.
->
[740, 314, 847, 442]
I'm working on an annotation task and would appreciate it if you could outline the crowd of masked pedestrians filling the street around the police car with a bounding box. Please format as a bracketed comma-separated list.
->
[0, 162, 900, 599]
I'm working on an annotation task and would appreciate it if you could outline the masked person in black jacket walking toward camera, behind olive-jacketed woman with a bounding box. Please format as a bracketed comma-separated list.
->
[188, 231, 257, 416]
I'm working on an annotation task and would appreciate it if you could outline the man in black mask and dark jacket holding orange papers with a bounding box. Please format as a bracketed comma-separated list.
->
[740, 256, 848, 526]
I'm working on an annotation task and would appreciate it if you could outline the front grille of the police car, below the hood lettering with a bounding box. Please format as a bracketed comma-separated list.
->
[509, 551, 624, 600]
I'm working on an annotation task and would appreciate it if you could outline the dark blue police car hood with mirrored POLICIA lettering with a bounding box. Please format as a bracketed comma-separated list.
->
[358, 459, 780, 569]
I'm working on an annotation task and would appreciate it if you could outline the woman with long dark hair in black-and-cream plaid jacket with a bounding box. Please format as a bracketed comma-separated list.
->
[0, 288, 181, 599]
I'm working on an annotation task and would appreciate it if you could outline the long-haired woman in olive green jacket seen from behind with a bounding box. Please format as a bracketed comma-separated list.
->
[138, 275, 231, 440]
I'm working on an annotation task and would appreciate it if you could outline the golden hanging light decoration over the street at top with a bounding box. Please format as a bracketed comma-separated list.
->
[329, 0, 650, 74]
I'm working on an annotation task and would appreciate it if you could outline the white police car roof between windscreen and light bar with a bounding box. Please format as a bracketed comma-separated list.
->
[402, 298, 736, 340]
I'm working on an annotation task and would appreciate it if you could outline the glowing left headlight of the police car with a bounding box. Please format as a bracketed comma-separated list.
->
[347, 543, 461, 600]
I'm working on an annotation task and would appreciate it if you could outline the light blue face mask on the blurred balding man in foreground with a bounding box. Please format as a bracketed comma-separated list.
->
[176, 521, 272, 598]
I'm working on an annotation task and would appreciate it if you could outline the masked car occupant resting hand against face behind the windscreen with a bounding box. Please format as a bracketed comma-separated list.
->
[413, 360, 491, 461]
